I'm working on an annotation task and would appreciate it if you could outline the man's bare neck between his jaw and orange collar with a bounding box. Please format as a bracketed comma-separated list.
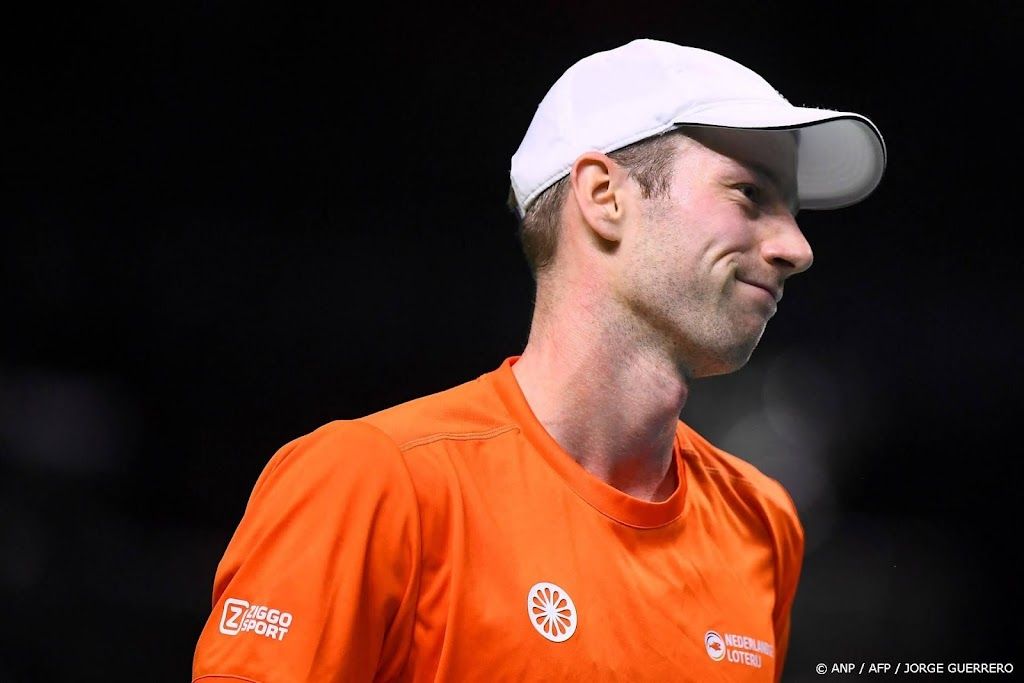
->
[512, 318, 688, 502]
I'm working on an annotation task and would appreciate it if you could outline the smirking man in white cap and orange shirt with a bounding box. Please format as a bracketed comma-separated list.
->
[194, 40, 885, 682]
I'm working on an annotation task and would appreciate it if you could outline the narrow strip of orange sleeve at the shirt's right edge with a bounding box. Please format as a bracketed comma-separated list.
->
[772, 484, 804, 683]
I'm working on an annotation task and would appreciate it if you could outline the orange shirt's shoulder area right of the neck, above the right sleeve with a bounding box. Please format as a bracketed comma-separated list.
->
[678, 421, 797, 517]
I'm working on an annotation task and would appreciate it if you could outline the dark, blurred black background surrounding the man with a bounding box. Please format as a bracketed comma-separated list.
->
[0, 2, 1024, 681]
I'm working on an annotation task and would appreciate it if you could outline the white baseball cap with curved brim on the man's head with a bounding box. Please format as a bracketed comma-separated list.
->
[510, 39, 886, 216]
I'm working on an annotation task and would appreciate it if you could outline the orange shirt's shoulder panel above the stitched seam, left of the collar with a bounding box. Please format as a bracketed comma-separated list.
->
[356, 366, 512, 451]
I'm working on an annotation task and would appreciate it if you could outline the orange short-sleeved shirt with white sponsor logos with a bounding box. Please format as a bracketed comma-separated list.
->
[193, 356, 803, 683]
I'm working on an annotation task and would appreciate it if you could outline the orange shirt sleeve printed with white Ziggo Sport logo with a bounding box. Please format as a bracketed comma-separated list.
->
[193, 421, 420, 683]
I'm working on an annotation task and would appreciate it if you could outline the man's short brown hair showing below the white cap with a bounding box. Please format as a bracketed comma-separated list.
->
[508, 129, 688, 281]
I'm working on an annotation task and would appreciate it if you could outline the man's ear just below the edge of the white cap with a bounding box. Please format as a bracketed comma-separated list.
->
[569, 152, 629, 242]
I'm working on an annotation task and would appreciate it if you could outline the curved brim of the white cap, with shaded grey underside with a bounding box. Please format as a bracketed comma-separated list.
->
[673, 101, 886, 209]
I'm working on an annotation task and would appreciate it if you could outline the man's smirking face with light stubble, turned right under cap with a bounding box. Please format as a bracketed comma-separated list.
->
[616, 129, 812, 377]
